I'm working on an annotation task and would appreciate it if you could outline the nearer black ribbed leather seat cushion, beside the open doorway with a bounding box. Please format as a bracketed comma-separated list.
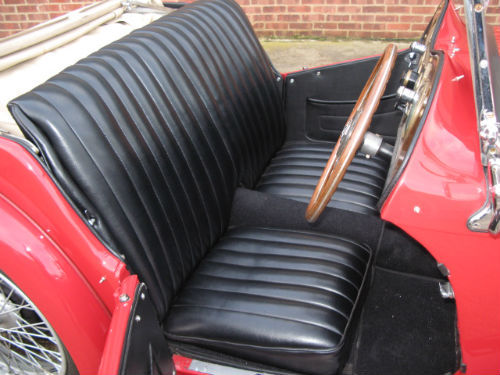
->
[165, 228, 371, 374]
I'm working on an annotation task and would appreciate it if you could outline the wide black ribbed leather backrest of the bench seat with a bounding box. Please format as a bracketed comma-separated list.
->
[9, 0, 284, 316]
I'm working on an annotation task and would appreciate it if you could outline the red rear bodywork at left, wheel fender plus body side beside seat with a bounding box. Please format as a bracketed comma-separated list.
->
[0, 137, 128, 374]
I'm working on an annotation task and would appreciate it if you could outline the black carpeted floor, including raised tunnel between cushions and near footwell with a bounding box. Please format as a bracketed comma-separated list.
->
[231, 189, 460, 375]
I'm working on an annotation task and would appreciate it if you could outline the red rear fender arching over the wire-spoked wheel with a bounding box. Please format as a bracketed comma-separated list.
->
[0, 195, 110, 374]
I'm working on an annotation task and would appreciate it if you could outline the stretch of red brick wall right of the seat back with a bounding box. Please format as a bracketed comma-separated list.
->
[243, 0, 500, 39]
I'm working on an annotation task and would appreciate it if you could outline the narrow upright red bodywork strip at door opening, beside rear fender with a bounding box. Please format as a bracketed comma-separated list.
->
[98, 275, 139, 375]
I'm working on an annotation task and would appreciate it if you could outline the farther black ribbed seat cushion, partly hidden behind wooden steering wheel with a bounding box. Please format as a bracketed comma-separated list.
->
[256, 143, 389, 214]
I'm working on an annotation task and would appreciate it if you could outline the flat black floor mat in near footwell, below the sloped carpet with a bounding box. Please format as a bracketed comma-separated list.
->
[352, 268, 458, 375]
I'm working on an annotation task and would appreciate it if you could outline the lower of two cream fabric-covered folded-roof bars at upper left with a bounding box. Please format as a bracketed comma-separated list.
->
[0, 8, 124, 71]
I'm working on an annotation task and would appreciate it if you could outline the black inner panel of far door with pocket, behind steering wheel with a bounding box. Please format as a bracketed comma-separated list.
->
[284, 51, 408, 143]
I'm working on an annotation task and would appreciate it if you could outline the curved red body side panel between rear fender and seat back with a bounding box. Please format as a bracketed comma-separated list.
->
[0, 137, 129, 312]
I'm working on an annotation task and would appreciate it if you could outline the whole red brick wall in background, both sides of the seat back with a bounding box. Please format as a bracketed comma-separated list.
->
[0, 0, 500, 39]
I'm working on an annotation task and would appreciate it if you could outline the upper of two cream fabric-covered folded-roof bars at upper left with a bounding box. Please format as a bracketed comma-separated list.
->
[0, 0, 122, 57]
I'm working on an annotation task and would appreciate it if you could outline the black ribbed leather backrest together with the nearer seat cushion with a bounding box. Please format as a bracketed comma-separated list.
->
[9, 0, 376, 374]
